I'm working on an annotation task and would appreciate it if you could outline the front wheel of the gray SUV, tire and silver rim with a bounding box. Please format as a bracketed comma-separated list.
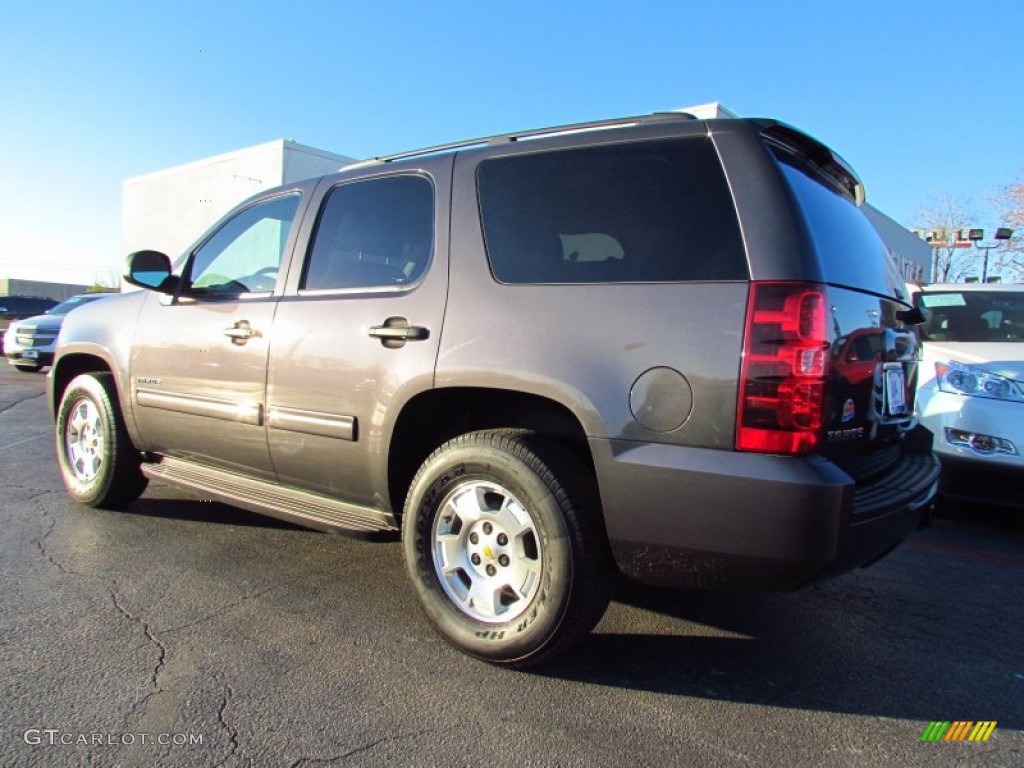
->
[56, 373, 147, 509]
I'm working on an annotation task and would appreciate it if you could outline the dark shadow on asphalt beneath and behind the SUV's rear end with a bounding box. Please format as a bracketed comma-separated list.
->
[535, 580, 1024, 730]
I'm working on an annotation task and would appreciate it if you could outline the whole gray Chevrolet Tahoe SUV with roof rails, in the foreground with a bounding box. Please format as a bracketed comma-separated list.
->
[49, 115, 938, 667]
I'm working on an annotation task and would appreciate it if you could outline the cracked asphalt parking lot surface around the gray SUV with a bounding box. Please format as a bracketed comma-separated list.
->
[0, 366, 1024, 768]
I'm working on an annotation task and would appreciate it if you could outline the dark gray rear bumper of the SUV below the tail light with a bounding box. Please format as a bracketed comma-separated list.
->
[591, 439, 939, 590]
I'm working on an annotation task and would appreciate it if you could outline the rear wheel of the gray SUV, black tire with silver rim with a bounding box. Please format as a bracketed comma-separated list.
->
[402, 430, 611, 668]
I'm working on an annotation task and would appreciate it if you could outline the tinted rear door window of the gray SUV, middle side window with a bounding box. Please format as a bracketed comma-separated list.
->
[302, 175, 434, 291]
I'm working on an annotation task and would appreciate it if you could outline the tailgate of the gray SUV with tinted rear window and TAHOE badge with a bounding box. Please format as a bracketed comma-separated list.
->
[770, 135, 919, 479]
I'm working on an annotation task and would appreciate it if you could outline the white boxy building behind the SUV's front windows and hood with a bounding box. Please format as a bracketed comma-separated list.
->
[122, 139, 352, 259]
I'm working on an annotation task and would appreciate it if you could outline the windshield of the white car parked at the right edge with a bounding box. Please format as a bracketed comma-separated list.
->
[918, 291, 1024, 342]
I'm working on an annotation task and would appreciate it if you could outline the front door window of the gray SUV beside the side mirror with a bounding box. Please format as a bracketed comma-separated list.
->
[186, 195, 299, 295]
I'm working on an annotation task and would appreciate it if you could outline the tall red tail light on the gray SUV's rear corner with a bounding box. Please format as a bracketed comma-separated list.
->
[736, 283, 828, 454]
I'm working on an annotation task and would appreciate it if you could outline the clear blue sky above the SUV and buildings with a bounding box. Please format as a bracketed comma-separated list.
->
[0, 0, 1024, 282]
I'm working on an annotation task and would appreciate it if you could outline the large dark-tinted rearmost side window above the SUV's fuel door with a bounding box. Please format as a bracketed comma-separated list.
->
[477, 138, 749, 283]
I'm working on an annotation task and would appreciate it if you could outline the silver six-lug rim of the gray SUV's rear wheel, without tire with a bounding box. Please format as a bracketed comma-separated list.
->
[432, 480, 543, 624]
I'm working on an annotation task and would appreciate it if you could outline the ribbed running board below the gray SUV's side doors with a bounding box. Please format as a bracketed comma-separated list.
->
[142, 457, 398, 534]
